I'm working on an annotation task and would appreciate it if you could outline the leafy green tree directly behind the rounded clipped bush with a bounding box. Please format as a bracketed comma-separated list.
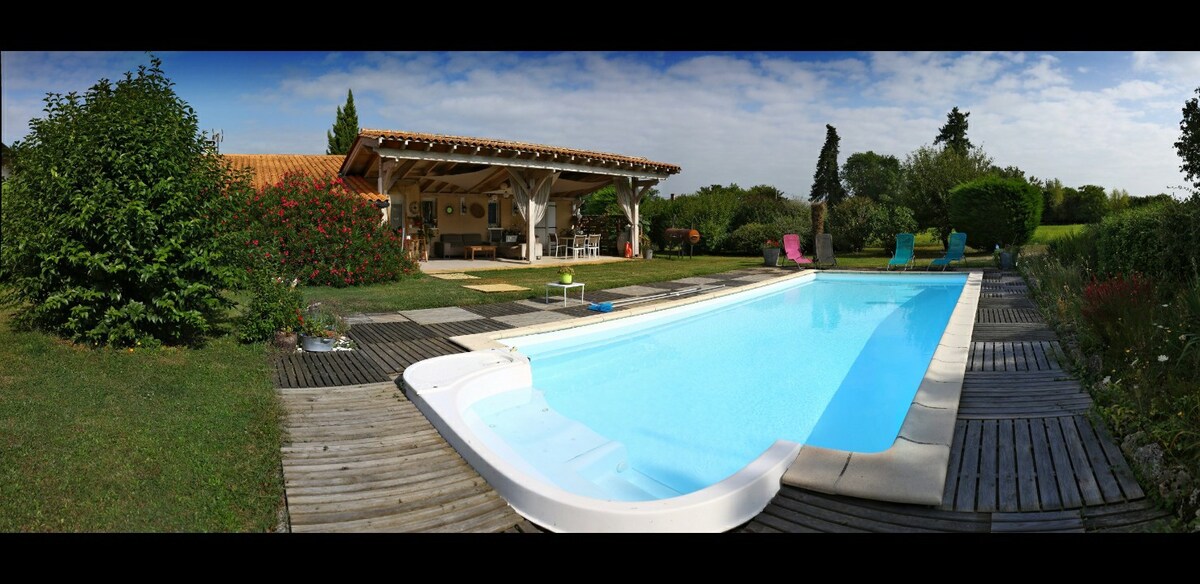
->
[901, 146, 991, 246]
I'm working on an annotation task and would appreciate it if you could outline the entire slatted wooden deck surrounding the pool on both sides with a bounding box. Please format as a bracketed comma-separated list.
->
[276, 269, 1168, 532]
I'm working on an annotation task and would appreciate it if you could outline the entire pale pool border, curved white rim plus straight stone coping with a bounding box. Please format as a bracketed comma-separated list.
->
[403, 270, 983, 531]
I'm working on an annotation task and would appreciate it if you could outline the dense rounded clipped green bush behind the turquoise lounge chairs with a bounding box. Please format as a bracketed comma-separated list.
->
[949, 176, 1042, 249]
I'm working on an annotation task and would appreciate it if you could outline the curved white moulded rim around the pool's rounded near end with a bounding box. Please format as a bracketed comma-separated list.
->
[403, 348, 800, 532]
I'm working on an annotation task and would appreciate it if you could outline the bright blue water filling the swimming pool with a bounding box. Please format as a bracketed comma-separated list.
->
[470, 273, 966, 500]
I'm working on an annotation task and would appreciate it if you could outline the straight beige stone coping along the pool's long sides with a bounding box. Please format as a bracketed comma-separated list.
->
[450, 270, 983, 505]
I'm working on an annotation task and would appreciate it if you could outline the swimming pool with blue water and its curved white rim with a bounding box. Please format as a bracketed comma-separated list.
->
[404, 273, 973, 530]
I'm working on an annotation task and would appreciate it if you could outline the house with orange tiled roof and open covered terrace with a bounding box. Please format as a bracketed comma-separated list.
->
[224, 130, 680, 259]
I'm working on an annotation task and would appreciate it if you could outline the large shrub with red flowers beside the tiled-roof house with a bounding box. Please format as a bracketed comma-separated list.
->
[234, 171, 418, 288]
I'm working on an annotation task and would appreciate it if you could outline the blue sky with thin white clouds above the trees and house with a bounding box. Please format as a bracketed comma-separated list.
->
[0, 52, 1200, 197]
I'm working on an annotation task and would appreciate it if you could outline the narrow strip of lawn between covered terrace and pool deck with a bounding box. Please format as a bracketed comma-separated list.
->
[305, 255, 762, 315]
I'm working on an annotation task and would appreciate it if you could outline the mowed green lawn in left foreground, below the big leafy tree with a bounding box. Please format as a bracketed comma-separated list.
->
[0, 311, 283, 531]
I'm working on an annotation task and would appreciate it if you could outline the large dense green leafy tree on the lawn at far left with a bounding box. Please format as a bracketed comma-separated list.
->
[0, 56, 250, 345]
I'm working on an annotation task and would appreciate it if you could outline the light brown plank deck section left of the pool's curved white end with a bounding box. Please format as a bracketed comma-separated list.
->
[280, 381, 524, 532]
